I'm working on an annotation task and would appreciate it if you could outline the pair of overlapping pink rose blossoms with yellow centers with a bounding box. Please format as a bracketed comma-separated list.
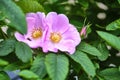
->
[15, 12, 81, 54]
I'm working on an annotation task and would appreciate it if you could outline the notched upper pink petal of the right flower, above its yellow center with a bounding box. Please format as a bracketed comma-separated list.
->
[46, 12, 69, 33]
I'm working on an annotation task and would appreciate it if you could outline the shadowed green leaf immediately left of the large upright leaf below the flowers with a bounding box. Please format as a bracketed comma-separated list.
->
[30, 54, 47, 78]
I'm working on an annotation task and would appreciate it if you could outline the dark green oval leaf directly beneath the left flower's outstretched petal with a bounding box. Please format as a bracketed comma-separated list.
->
[15, 42, 32, 62]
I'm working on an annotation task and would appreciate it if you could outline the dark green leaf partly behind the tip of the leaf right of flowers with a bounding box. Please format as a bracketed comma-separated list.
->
[98, 43, 109, 61]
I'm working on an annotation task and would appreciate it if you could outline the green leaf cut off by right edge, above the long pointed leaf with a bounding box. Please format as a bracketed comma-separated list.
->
[106, 19, 120, 30]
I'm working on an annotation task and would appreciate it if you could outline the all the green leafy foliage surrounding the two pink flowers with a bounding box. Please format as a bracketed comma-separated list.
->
[0, 0, 120, 80]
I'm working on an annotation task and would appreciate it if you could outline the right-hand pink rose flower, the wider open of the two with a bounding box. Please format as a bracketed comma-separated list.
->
[43, 12, 81, 54]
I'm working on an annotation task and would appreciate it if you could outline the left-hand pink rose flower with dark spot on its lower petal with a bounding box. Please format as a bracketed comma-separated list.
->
[15, 12, 47, 48]
